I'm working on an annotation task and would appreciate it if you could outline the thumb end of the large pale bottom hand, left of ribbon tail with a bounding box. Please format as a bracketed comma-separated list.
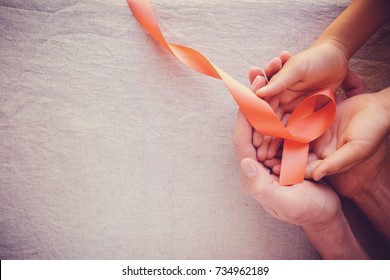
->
[241, 158, 273, 197]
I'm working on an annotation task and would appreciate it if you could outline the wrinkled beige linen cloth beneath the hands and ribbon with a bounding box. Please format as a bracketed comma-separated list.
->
[0, 0, 390, 259]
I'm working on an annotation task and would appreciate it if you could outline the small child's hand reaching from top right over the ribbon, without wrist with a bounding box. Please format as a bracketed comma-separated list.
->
[256, 41, 348, 112]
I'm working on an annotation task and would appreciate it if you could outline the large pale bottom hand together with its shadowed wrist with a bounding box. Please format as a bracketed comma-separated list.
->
[234, 111, 367, 259]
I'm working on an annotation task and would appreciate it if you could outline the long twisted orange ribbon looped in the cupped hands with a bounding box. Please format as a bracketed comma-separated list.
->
[127, 0, 336, 185]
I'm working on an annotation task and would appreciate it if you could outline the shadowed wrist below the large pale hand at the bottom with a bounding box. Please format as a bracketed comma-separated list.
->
[302, 209, 368, 259]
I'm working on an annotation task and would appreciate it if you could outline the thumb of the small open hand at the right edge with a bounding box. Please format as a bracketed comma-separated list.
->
[313, 142, 371, 181]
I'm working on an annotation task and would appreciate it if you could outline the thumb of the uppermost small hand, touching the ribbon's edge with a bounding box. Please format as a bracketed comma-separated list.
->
[256, 60, 302, 98]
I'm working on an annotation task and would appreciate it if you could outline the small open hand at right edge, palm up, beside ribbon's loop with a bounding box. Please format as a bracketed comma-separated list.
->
[308, 88, 390, 183]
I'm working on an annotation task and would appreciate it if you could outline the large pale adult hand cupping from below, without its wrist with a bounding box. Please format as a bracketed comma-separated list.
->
[234, 111, 341, 228]
